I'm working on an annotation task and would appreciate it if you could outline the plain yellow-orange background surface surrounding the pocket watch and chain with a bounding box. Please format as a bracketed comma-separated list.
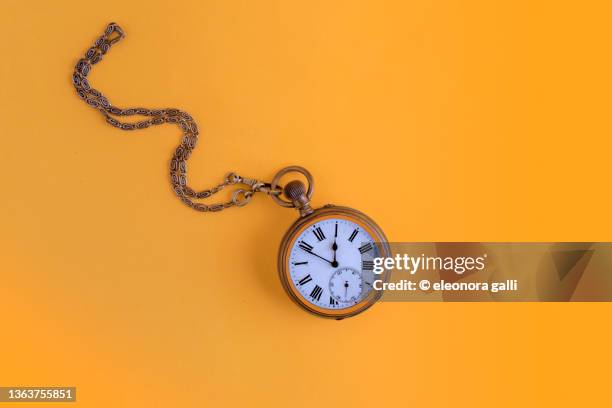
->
[0, 0, 612, 407]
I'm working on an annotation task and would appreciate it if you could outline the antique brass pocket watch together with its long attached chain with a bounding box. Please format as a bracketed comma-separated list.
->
[72, 23, 390, 319]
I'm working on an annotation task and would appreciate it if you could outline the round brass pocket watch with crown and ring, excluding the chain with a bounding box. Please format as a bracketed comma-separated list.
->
[271, 166, 390, 319]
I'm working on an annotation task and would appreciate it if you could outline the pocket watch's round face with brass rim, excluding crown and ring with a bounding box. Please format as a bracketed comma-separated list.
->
[281, 208, 384, 317]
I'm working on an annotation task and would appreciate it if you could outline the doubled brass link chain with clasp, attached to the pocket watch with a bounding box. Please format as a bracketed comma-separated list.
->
[72, 23, 282, 212]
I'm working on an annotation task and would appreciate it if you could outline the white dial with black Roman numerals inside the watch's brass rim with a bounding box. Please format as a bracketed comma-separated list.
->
[289, 218, 378, 309]
